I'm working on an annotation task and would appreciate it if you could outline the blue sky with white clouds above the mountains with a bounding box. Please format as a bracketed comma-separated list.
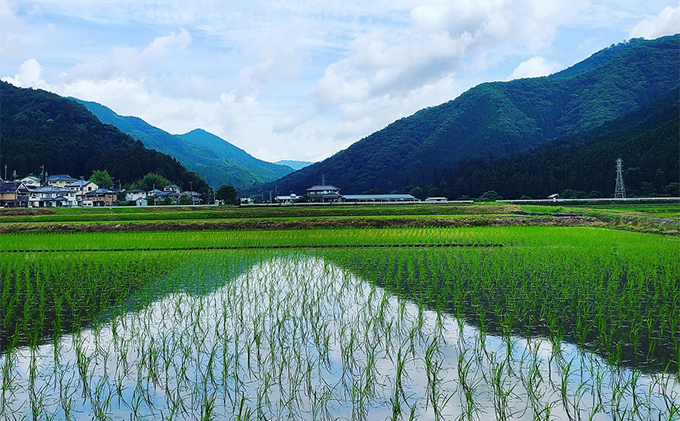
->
[0, 0, 680, 161]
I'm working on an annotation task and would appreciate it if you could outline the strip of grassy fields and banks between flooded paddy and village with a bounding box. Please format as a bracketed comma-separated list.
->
[0, 203, 680, 234]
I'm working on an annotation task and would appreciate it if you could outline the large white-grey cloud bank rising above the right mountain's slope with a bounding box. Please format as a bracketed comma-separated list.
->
[314, 0, 588, 142]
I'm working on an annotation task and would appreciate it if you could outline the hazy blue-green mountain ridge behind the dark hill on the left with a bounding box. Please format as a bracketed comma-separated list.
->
[72, 98, 292, 189]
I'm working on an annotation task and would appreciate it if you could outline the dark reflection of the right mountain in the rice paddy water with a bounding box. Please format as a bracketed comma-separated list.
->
[320, 248, 678, 372]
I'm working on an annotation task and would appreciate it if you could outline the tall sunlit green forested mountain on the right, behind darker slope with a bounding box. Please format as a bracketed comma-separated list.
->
[264, 35, 680, 194]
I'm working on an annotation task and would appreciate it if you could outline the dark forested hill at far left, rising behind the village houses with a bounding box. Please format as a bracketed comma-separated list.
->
[0, 82, 209, 192]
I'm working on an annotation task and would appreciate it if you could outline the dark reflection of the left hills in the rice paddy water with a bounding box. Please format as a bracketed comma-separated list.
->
[0, 251, 271, 354]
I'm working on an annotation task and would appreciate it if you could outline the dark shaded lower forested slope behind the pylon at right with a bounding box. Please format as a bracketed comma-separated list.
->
[438, 86, 680, 199]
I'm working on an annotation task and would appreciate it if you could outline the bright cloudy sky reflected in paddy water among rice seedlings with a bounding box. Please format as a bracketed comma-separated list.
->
[0, 257, 680, 420]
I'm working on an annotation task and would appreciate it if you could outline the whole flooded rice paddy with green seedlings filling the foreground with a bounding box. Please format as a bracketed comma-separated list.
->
[0, 206, 680, 420]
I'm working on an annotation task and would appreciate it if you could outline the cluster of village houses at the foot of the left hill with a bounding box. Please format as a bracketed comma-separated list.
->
[0, 174, 203, 208]
